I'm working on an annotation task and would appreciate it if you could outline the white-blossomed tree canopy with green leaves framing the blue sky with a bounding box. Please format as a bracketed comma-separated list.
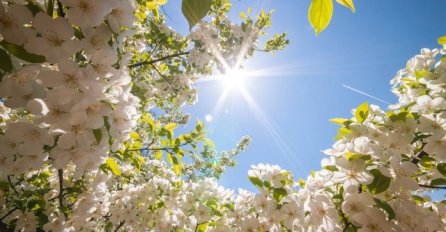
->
[0, 0, 446, 231]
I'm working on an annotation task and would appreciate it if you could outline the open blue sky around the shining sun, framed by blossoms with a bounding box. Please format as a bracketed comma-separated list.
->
[165, 0, 446, 190]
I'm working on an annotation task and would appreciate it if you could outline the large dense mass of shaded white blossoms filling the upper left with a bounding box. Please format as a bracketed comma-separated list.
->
[0, 0, 139, 177]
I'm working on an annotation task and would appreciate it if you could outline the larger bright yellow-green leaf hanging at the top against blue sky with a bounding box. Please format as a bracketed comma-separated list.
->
[308, 0, 333, 35]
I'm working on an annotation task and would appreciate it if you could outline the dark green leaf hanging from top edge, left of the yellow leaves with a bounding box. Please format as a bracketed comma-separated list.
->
[181, 0, 212, 29]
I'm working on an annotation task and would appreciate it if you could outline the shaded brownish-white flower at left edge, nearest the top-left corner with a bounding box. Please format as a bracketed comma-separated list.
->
[0, 1, 33, 45]
